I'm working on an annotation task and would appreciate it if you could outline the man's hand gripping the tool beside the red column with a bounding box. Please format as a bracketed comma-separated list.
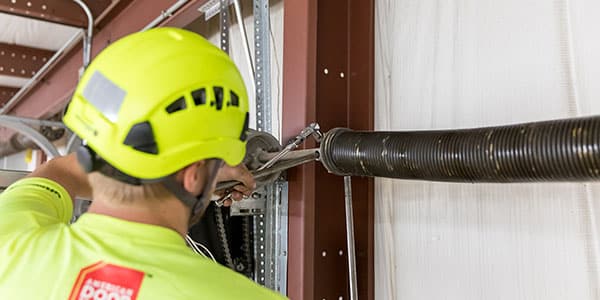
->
[215, 164, 256, 206]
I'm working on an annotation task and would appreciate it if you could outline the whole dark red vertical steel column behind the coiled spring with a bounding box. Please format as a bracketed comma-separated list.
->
[283, 0, 374, 299]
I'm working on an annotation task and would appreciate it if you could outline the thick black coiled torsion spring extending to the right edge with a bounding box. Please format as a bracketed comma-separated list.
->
[321, 116, 600, 182]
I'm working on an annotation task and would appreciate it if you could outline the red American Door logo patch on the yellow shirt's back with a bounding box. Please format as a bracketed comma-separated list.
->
[69, 261, 144, 300]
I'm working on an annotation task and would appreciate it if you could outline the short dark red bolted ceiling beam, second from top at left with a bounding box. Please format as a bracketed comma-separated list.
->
[0, 42, 54, 78]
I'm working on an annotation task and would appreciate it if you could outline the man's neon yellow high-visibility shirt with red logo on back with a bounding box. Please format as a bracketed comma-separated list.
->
[0, 178, 284, 300]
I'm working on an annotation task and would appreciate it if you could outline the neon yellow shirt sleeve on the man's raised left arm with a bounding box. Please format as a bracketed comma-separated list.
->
[0, 177, 73, 242]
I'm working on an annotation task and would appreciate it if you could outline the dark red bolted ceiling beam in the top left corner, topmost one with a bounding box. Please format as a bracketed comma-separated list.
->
[0, 0, 112, 28]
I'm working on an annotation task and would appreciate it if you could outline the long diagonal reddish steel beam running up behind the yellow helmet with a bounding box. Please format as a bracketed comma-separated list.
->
[0, 0, 211, 140]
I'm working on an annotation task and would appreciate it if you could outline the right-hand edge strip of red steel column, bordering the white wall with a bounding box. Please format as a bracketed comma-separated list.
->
[348, 0, 375, 299]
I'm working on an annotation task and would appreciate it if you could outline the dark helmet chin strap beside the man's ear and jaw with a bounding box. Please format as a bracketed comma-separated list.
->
[162, 159, 223, 227]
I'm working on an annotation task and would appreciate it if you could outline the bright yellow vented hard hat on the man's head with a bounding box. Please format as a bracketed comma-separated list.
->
[64, 28, 248, 179]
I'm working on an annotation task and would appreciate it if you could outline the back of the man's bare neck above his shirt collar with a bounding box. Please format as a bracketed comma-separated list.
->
[88, 198, 190, 237]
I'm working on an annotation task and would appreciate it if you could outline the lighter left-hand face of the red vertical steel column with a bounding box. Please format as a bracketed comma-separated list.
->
[282, 0, 317, 300]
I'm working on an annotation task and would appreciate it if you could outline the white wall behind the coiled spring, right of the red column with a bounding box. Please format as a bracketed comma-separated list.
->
[375, 0, 600, 300]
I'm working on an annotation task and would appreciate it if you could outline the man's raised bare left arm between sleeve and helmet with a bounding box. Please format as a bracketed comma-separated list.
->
[27, 153, 92, 199]
